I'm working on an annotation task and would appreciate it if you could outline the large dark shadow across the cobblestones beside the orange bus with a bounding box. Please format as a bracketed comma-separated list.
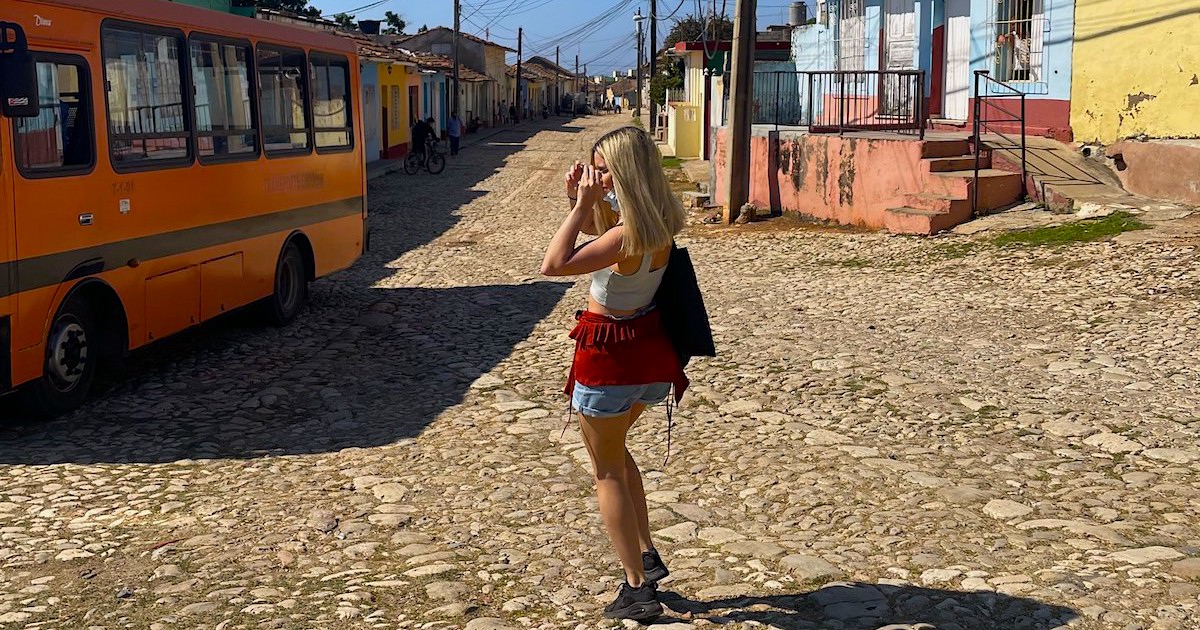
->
[0, 116, 582, 464]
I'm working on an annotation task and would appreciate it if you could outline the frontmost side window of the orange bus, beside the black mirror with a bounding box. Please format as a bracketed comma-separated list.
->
[14, 54, 96, 178]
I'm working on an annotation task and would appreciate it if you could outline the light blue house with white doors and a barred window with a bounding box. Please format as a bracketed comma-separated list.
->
[806, 0, 1075, 140]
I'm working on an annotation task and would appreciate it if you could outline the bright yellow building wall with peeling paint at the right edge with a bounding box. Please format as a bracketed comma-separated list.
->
[1070, 0, 1200, 144]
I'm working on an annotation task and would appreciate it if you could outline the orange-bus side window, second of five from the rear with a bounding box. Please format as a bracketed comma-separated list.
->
[258, 46, 308, 155]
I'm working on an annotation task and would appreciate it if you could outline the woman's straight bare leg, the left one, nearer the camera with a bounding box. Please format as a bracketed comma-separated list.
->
[580, 414, 646, 588]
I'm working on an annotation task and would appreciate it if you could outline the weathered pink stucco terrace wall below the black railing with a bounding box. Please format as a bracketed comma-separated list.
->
[713, 127, 928, 229]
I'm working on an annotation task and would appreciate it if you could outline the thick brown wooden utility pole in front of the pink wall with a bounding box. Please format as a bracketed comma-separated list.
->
[722, 0, 757, 224]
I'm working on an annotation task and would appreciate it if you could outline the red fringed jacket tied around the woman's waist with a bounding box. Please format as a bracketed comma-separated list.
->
[565, 311, 688, 402]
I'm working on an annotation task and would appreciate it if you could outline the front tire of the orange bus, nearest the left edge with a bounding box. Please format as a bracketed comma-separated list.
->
[23, 295, 102, 418]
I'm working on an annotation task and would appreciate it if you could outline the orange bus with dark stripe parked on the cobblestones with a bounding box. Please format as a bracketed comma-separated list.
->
[0, 0, 367, 415]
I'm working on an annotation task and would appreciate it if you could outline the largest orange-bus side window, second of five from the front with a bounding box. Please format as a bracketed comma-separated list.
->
[103, 25, 192, 170]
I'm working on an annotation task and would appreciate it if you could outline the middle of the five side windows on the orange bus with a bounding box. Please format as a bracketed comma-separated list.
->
[191, 37, 258, 162]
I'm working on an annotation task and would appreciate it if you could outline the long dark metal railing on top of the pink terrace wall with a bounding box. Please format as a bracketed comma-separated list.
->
[754, 70, 926, 138]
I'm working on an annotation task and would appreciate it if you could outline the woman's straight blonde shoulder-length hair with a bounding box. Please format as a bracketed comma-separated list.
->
[592, 126, 686, 256]
